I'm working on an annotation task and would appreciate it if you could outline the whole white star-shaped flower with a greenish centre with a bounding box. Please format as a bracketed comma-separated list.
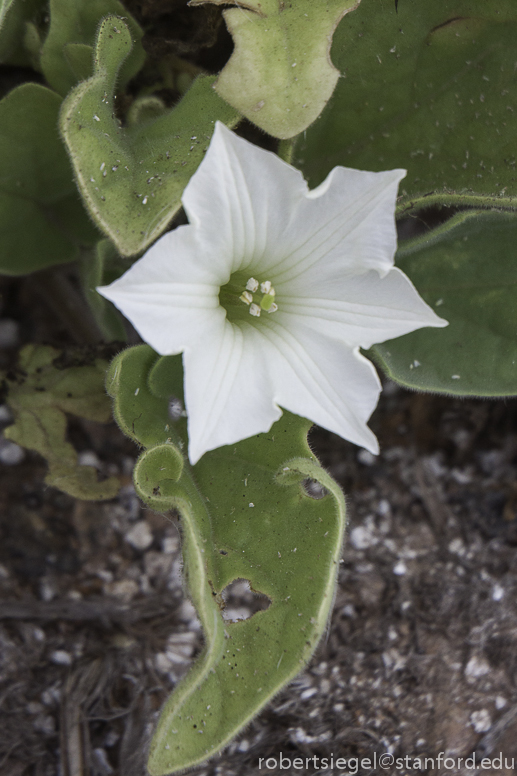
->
[98, 123, 447, 463]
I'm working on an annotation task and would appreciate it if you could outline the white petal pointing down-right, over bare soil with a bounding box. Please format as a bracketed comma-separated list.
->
[261, 320, 381, 453]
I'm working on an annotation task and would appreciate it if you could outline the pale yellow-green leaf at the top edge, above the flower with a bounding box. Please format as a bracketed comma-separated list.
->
[189, 0, 361, 138]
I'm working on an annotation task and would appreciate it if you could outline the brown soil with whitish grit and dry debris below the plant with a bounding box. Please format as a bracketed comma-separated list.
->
[0, 284, 517, 776]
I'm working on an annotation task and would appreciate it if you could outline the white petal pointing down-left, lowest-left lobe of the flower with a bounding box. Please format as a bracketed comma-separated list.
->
[183, 321, 282, 464]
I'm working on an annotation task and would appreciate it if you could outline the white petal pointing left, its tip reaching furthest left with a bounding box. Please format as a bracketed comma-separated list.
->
[97, 226, 225, 356]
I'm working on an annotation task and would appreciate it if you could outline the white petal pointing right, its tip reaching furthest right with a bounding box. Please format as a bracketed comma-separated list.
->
[276, 262, 447, 348]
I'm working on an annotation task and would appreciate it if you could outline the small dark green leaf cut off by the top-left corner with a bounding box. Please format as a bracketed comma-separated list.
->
[0, 0, 45, 66]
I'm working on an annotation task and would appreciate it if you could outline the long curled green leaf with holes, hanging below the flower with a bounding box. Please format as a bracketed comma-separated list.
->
[108, 345, 345, 776]
